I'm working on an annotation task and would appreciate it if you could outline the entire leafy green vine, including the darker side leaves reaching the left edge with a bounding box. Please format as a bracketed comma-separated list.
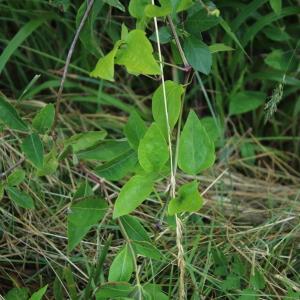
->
[0, 0, 230, 299]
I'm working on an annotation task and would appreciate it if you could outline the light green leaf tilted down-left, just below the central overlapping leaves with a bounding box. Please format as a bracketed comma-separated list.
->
[113, 175, 153, 219]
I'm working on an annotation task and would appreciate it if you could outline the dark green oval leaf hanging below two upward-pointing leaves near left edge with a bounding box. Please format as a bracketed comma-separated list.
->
[21, 133, 44, 169]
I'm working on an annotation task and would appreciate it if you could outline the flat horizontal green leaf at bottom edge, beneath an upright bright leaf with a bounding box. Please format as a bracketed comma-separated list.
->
[96, 282, 133, 300]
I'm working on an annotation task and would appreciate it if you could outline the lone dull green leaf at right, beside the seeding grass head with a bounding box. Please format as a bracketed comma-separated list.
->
[229, 91, 266, 115]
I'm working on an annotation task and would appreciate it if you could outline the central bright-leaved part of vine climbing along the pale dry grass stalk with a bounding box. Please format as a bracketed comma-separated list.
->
[86, 0, 218, 299]
